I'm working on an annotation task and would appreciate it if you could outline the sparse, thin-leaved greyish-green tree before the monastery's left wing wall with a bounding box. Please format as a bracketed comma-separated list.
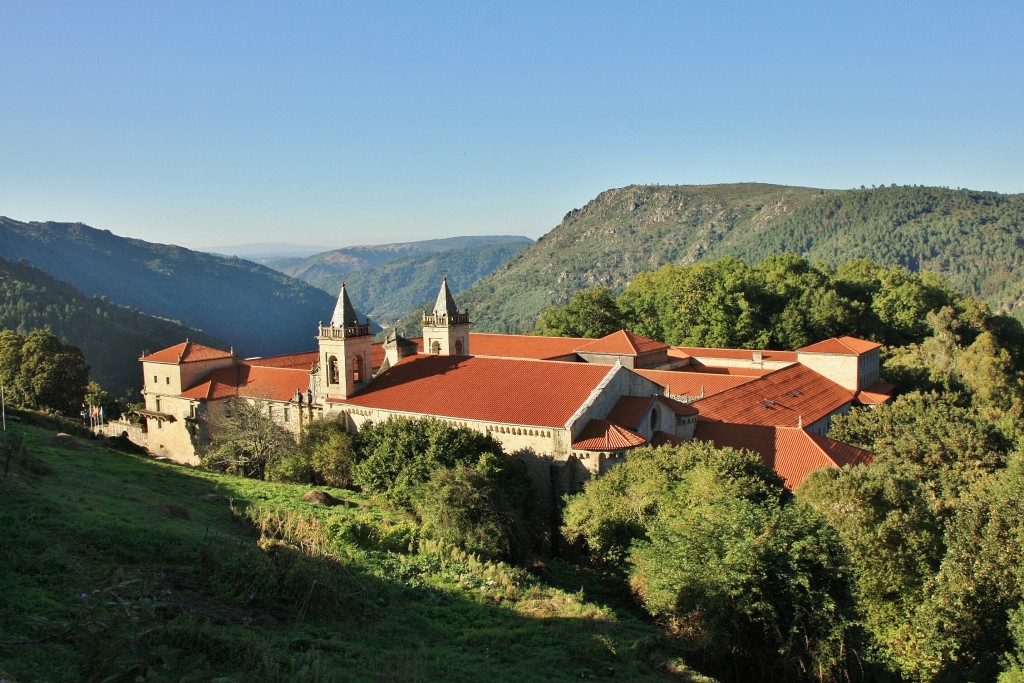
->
[203, 397, 296, 479]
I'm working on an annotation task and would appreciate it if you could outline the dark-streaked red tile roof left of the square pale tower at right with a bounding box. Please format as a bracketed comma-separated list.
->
[696, 365, 853, 427]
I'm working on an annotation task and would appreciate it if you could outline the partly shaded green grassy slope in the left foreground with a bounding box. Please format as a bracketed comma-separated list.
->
[0, 426, 693, 681]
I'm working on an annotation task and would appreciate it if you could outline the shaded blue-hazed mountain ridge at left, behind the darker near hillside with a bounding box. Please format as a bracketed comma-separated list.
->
[0, 217, 335, 357]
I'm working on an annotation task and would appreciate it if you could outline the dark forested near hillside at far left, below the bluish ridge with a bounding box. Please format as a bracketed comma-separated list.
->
[0, 258, 226, 394]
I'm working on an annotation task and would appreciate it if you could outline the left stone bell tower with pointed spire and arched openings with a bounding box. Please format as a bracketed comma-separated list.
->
[316, 283, 374, 398]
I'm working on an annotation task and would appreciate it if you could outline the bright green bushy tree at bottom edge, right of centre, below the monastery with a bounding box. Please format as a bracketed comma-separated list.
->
[630, 497, 855, 681]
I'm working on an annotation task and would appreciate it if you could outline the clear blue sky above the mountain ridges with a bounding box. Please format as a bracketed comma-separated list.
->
[0, 0, 1024, 248]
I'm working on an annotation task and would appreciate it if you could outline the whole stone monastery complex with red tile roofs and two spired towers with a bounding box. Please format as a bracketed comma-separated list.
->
[139, 281, 893, 501]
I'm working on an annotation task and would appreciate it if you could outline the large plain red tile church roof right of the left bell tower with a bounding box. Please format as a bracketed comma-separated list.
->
[336, 355, 620, 427]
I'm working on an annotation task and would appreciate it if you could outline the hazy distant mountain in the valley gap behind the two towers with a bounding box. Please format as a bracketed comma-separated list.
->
[265, 234, 532, 293]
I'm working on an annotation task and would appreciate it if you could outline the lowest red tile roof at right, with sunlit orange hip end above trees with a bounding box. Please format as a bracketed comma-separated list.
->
[694, 422, 873, 490]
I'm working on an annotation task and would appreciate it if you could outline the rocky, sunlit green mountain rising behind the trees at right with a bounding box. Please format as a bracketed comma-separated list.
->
[452, 183, 1024, 332]
